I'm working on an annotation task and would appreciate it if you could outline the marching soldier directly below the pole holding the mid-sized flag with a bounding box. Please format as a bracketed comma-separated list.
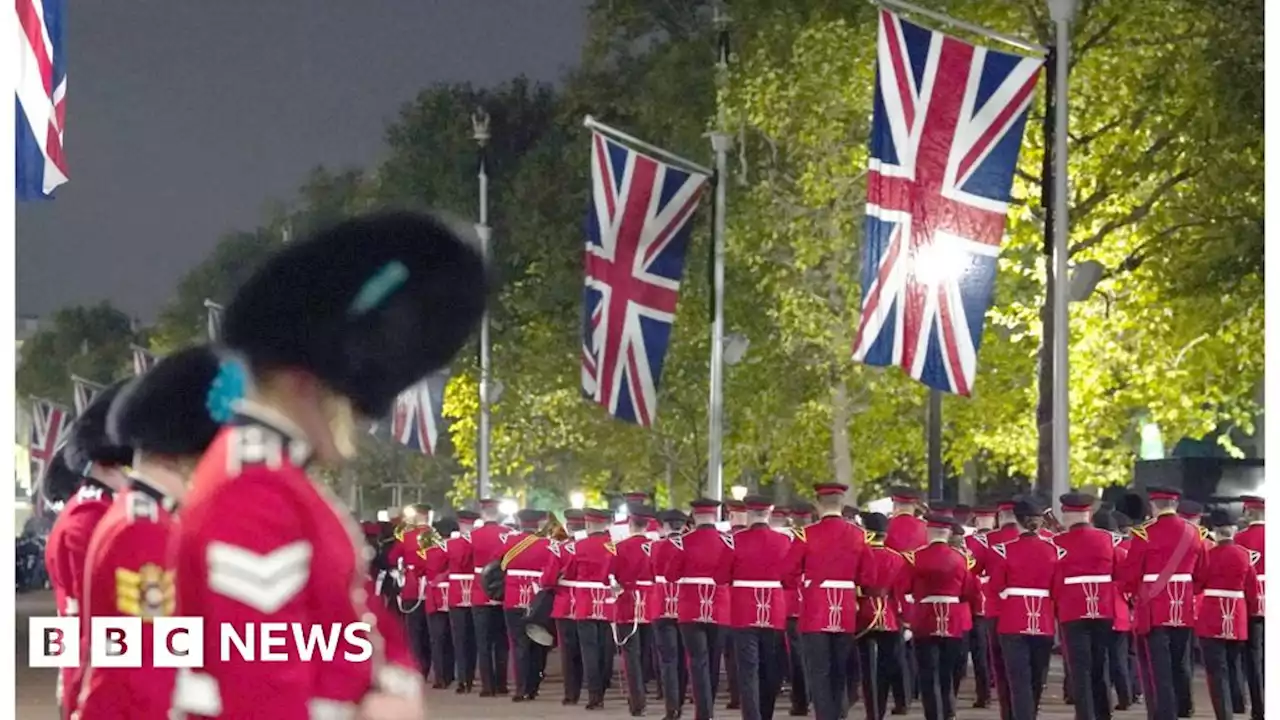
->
[666, 498, 733, 720]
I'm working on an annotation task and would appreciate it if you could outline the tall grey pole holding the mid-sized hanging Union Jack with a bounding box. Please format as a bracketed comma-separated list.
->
[707, 3, 733, 500]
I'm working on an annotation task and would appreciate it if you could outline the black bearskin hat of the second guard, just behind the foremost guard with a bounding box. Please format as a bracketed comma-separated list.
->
[108, 346, 220, 457]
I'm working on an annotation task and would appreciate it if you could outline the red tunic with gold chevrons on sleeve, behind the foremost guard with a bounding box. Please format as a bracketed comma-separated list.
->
[76, 484, 175, 720]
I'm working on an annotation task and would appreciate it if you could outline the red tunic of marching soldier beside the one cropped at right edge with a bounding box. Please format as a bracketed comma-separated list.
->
[1193, 542, 1258, 641]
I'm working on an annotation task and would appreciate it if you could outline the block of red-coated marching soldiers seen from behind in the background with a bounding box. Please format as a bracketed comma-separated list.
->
[376, 483, 1265, 720]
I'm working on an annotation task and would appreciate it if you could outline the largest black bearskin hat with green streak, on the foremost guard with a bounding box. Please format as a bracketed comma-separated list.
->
[223, 211, 490, 418]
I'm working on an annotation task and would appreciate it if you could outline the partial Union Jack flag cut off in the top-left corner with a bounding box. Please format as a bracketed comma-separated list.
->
[14, 0, 67, 200]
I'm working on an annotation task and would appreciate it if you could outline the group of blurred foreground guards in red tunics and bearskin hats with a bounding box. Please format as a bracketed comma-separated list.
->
[42, 211, 490, 720]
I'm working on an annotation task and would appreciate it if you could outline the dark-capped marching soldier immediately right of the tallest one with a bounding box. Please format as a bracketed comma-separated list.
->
[856, 512, 908, 720]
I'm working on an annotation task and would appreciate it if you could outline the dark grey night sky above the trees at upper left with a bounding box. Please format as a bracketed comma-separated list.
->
[18, 0, 588, 320]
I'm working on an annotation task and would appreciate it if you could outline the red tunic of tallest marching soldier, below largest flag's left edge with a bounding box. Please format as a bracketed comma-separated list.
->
[787, 515, 867, 633]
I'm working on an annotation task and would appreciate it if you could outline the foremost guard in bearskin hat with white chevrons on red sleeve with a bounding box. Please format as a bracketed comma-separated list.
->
[172, 213, 488, 719]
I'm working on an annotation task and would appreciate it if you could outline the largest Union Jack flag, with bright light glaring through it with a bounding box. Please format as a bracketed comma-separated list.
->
[854, 12, 1042, 396]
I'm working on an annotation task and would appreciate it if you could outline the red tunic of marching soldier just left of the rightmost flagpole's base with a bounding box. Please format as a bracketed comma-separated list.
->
[987, 533, 1062, 635]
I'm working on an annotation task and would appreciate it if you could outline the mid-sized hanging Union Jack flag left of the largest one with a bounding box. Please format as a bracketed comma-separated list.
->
[582, 132, 708, 427]
